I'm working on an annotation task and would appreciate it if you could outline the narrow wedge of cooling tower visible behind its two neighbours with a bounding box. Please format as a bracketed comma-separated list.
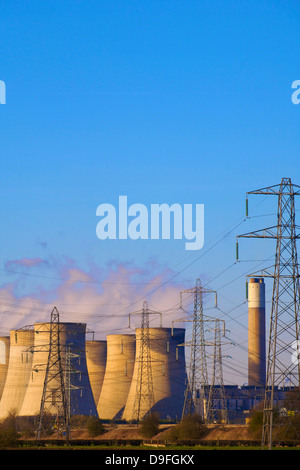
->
[85, 340, 107, 403]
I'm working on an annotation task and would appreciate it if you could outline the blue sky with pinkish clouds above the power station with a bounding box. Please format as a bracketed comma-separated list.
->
[0, 0, 300, 383]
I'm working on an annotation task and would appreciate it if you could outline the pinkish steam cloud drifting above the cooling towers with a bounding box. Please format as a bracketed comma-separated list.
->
[0, 258, 186, 339]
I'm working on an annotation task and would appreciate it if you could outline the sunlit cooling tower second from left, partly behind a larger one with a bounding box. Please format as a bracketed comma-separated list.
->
[0, 329, 34, 419]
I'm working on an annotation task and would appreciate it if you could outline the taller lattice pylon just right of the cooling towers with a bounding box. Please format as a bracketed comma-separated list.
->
[178, 279, 216, 421]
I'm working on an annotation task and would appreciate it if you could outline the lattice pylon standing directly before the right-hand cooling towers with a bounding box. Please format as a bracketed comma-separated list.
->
[129, 300, 161, 423]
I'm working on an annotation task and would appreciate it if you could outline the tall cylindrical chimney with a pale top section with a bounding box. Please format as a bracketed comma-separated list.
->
[248, 278, 266, 386]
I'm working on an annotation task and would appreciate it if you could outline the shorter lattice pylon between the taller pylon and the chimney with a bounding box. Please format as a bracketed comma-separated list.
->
[207, 319, 228, 424]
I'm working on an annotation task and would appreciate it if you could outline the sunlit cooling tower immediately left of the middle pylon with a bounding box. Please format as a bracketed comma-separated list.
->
[97, 335, 135, 419]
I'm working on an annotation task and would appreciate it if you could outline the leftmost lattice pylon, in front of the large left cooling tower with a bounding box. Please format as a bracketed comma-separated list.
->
[36, 307, 70, 439]
